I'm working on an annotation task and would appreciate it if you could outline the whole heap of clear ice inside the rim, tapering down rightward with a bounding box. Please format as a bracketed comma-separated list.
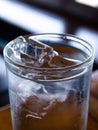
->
[9, 36, 76, 68]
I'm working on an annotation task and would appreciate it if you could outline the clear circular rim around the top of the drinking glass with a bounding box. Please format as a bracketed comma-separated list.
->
[3, 33, 95, 71]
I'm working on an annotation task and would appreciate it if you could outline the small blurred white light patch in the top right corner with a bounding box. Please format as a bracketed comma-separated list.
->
[75, 0, 98, 7]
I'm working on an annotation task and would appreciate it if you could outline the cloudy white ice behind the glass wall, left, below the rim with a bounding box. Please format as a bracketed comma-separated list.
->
[16, 80, 47, 101]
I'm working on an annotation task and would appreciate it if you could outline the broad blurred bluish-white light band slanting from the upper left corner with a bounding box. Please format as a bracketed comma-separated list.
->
[0, 0, 66, 33]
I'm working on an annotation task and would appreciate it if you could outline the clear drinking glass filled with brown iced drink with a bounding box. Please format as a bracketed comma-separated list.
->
[4, 34, 94, 130]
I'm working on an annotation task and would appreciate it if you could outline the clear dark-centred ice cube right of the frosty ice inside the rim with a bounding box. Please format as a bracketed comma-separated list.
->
[21, 37, 58, 67]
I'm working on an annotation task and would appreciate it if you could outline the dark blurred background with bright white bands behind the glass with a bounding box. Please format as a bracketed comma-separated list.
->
[0, 0, 98, 107]
